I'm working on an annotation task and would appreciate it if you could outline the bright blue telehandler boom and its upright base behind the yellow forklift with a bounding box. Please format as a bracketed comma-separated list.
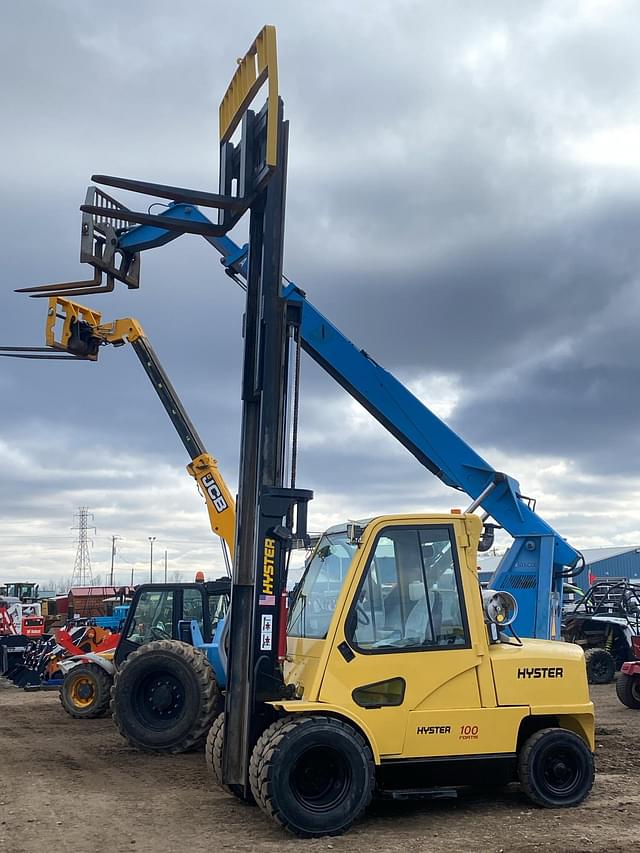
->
[106, 204, 581, 640]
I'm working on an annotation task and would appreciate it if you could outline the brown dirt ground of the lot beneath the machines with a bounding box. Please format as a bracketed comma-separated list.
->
[0, 679, 640, 853]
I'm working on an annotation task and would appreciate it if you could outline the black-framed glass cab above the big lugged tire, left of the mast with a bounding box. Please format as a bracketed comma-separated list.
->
[115, 578, 231, 667]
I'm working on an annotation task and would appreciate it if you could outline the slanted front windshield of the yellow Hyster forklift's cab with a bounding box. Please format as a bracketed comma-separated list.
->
[287, 530, 356, 639]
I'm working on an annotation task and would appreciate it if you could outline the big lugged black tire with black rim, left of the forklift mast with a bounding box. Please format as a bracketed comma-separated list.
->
[111, 640, 222, 753]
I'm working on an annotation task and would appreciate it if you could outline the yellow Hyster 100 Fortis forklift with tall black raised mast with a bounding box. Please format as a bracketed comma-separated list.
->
[207, 28, 594, 836]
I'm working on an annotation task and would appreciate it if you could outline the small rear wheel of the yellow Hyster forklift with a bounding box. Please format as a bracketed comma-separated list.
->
[518, 728, 595, 808]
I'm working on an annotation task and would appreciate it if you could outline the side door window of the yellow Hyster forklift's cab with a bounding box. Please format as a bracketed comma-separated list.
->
[347, 526, 468, 652]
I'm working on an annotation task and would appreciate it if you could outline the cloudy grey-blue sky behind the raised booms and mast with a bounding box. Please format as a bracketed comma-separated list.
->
[0, 0, 640, 583]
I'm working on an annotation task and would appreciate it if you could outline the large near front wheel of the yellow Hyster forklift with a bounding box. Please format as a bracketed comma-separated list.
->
[249, 715, 375, 838]
